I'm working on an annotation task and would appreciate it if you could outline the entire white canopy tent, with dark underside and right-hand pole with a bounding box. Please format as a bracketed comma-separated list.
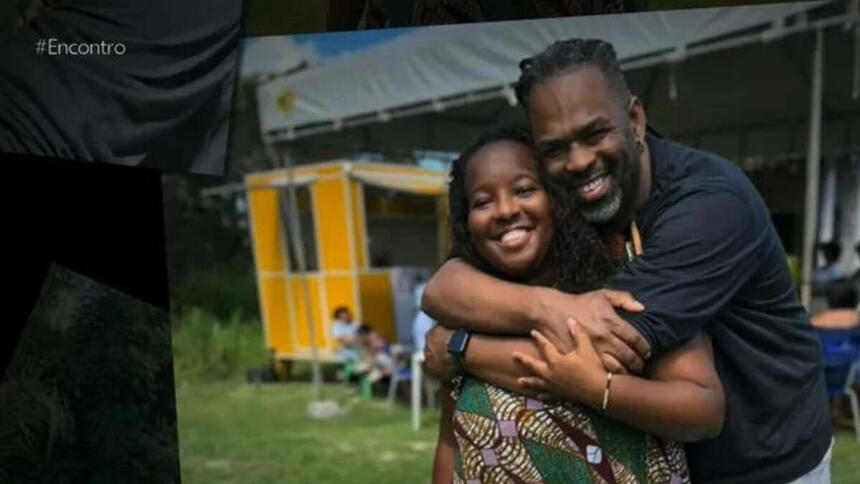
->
[258, 2, 857, 308]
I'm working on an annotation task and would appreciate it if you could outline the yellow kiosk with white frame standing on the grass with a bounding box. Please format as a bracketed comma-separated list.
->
[245, 161, 448, 377]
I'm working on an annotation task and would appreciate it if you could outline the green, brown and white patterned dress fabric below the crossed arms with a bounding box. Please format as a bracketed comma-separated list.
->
[452, 378, 689, 484]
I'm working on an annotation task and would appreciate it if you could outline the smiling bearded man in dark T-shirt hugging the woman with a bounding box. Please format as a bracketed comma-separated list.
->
[424, 39, 832, 483]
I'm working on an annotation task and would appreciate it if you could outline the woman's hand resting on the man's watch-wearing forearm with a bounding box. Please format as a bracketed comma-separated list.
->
[513, 319, 607, 408]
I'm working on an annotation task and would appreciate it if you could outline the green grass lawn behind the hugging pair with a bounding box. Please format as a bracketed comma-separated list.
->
[173, 311, 860, 484]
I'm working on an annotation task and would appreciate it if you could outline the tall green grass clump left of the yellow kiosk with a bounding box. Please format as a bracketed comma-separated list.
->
[173, 307, 268, 380]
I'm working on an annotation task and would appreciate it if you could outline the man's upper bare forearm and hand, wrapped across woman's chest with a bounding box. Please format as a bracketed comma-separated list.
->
[422, 259, 650, 372]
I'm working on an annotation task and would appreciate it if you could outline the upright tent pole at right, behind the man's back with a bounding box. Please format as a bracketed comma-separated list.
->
[800, 28, 824, 310]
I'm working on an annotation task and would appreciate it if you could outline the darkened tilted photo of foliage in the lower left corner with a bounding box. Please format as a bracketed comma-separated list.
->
[0, 266, 179, 483]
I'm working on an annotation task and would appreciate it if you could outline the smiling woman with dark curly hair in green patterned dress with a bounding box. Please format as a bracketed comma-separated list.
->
[434, 128, 724, 483]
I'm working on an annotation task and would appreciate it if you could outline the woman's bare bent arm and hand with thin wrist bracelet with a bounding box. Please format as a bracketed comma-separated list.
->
[515, 323, 725, 442]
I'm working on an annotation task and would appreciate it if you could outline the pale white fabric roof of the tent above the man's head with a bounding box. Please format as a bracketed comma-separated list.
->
[258, 2, 822, 140]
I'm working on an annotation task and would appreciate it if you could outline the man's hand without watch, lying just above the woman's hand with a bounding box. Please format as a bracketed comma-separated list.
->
[535, 289, 651, 373]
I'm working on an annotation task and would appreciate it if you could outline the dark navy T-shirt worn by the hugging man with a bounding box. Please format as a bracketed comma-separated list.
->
[611, 136, 832, 483]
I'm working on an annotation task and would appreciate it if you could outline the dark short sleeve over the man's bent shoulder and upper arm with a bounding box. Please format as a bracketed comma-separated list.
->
[610, 184, 764, 355]
